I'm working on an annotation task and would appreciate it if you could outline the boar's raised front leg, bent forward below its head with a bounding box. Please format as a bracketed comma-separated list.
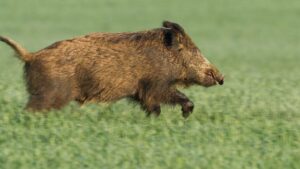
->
[168, 90, 194, 118]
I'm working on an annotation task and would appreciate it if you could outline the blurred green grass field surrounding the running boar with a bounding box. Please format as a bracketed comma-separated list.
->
[0, 0, 300, 169]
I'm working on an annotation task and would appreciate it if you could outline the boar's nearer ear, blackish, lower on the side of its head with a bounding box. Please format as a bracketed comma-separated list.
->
[163, 28, 182, 50]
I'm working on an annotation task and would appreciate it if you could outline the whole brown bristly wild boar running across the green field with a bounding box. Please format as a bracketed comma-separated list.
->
[0, 21, 224, 118]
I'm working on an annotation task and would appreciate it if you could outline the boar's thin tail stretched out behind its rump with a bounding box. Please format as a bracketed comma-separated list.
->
[0, 36, 32, 62]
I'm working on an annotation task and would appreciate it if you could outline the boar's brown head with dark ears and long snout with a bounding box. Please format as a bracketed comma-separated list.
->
[163, 21, 224, 87]
